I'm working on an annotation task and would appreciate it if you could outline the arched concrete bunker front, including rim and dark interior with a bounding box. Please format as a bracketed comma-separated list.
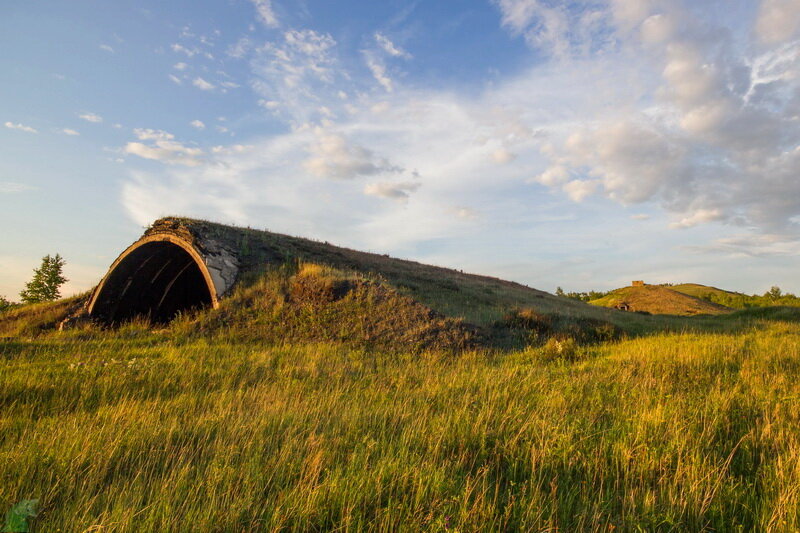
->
[87, 233, 236, 324]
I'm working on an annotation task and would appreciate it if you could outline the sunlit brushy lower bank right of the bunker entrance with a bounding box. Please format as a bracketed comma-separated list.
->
[189, 263, 478, 352]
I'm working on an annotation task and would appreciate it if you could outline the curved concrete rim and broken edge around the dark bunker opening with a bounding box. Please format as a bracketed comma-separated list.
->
[86, 232, 239, 315]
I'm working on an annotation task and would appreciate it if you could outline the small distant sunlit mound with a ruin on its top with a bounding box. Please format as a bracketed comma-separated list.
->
[589, 285, 730, 316]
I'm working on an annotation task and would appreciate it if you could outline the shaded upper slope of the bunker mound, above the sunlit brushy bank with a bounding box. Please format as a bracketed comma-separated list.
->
[148, 218, 647, 327]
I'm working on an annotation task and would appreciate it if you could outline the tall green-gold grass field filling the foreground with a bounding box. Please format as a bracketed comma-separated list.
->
[0, 310, 800, 532]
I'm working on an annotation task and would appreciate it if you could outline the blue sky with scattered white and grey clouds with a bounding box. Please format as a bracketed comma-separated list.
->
[0, 0, 800, 300]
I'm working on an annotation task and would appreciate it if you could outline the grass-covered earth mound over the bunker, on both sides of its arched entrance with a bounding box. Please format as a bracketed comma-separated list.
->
[0, 218, 688, 344]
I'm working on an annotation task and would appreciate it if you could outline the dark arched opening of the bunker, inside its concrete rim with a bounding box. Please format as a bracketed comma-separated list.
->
[91, 241, 212, 324]
